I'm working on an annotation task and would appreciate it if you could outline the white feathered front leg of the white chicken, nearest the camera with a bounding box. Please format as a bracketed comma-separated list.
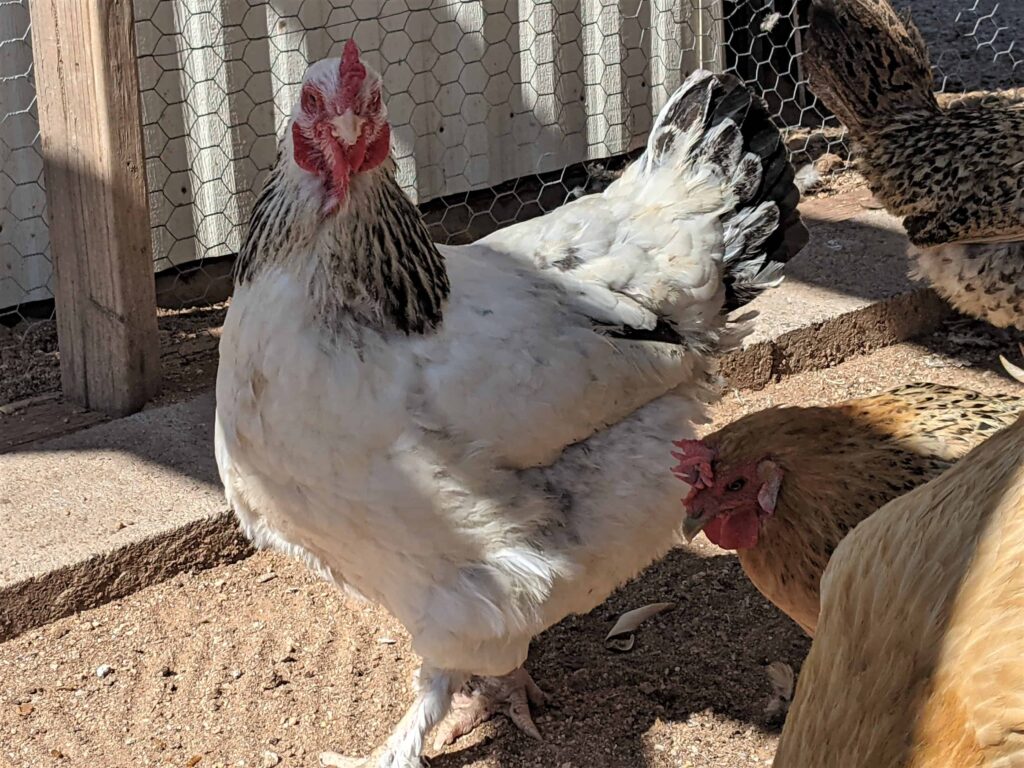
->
[319, 665, 467, 768]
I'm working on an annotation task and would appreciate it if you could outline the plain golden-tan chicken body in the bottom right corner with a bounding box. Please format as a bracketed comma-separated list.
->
[774, 411, 1024, 768]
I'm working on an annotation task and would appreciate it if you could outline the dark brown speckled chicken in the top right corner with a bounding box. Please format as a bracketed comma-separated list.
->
[804, 0, 1024, 330]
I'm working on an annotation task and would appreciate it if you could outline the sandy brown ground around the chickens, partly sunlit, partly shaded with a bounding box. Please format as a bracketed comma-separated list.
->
[0, 342, 1024, 768]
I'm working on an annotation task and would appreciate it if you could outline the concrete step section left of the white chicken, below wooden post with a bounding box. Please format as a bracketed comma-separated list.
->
[0, 393, 248, 640]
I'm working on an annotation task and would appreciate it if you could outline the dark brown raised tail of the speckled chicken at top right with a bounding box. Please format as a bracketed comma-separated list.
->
[798, 0, 939, 139]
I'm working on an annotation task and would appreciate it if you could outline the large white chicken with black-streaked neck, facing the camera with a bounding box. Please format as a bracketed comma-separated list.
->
[216, 42, 807, 768]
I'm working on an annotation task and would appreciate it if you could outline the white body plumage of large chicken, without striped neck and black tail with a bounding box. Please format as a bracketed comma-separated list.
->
[216, 69, 794, 688]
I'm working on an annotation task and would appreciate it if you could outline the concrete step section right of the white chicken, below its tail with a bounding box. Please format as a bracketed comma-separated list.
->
[722, 187, 951, 389]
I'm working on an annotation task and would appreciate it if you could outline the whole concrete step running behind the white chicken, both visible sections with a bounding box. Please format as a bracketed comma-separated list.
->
[0, 191, 948, 640]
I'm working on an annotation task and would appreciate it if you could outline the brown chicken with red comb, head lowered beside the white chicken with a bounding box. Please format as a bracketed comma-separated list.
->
[677, 384, 1024, 636]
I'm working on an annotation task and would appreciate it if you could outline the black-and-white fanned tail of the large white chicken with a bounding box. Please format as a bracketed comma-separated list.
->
[642, 70, 808, 310]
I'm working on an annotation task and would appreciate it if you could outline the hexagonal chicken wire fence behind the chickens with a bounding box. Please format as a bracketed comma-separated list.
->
[0, 0, 1024, 403]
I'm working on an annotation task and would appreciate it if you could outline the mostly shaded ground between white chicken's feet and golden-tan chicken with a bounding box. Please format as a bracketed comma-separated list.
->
[432, 549, 810, 768]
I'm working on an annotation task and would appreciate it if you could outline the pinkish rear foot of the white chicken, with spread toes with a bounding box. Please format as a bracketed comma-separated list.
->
[434, 667, 548, 750]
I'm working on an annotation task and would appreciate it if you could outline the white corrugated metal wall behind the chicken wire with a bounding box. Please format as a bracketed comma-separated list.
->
[0, 0, 721, 308]
